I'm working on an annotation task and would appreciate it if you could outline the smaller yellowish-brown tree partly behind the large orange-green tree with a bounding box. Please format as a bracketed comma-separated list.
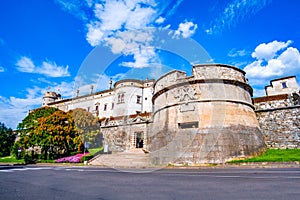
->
[73, 108, 102, 147]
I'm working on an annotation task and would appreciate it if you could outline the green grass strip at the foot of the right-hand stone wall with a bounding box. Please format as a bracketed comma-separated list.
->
[228, 149, 300, 163]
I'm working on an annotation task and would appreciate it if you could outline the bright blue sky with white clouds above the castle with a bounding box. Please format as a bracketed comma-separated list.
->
[0, 0, 300, 128]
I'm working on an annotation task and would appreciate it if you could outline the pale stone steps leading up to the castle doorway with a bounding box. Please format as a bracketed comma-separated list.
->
[88, 149, 151, 168]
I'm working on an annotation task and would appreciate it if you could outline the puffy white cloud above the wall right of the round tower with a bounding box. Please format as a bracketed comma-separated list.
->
[244, 41, 300, 85]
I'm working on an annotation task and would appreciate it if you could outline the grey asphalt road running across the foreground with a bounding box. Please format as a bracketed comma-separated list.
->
[0, 166, 300, 200]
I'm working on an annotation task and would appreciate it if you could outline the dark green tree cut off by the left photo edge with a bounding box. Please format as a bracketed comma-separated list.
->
[0, 122, 16, 156]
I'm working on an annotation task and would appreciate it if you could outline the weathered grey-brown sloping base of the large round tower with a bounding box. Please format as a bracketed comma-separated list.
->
[150, 125, 265, 165]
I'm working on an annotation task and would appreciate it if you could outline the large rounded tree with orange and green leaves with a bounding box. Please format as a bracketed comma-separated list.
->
[15, 107, 83, 159]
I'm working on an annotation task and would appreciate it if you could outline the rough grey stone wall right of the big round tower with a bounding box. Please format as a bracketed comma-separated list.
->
[254, 94, 300, 149]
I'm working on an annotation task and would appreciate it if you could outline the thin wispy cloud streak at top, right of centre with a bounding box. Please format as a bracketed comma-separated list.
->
[205, 0, 272, 34]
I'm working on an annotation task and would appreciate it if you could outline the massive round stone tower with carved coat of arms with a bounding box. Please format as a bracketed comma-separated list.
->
[148, 64, 265, 165]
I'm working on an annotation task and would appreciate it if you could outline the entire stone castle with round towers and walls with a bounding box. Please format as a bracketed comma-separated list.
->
[43, 64, 300, 165]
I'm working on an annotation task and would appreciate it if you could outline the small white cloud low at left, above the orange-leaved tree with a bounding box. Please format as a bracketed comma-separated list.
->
[16, 56, 70, 77]
